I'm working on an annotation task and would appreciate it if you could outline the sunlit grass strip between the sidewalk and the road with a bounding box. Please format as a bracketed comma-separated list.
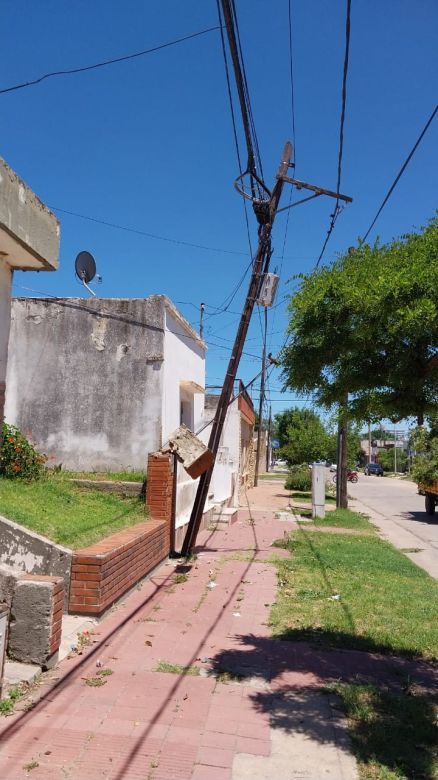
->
[271, 510, 438, 660]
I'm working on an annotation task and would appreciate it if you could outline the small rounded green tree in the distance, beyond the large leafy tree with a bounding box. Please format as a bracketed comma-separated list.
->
[274, 407, 330, 465]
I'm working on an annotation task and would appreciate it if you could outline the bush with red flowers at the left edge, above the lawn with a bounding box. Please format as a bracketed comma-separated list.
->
[0, 423, 47, 480]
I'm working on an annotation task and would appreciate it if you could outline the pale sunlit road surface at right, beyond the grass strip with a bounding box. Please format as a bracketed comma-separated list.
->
[348, 474, 438, 579]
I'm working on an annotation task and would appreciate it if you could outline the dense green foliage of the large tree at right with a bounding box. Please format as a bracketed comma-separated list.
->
[282, 218, 438, 421]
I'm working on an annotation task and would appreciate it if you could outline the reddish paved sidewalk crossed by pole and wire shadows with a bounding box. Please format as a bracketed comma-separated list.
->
[0, 490, 431, 780]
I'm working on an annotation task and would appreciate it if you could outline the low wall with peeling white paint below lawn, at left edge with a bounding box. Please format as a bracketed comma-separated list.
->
[0, 516, 73, 610]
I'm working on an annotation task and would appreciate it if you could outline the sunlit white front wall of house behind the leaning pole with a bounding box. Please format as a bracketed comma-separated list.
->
[162, 309, 205, 528]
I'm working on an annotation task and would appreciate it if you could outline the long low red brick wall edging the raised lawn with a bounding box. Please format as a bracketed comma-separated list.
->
[69, 520, 169, 615]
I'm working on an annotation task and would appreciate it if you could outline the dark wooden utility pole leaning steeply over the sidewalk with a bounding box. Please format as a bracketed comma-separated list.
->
[181, 142, 292, 556]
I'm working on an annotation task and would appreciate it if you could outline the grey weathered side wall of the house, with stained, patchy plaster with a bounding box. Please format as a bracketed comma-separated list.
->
[5, 296, 165, 471]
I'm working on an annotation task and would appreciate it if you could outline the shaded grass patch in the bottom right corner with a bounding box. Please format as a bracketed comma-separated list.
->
[330, 683, 438, 780]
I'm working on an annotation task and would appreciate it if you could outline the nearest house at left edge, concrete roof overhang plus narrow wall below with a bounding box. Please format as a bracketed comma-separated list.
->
[0, 158, 59, 425]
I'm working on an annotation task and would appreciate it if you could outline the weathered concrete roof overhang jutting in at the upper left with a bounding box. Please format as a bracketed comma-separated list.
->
[0, 157, 59, 271]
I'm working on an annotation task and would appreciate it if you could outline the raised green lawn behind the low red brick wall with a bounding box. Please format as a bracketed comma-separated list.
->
[0, 476, 145, 549]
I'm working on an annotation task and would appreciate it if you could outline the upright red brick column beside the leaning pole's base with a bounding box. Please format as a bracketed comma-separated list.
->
[146, 452, 176, 550]
